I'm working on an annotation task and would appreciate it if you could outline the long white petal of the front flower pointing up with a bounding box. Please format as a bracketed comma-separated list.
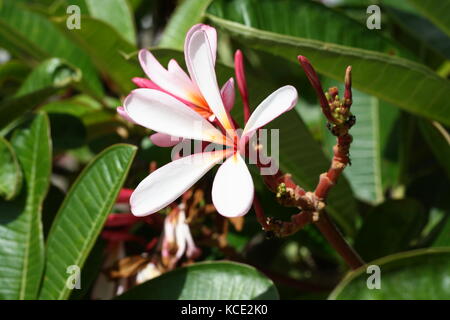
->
[185, 30, 233, 130]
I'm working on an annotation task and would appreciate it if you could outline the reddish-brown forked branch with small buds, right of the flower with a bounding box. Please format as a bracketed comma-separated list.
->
[253, 56, 364, 269]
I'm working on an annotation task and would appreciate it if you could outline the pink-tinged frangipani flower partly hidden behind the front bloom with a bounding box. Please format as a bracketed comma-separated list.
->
[117, 24, 235, 147]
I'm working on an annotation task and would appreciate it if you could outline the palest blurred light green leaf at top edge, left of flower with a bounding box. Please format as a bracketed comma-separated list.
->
[83, 0, 136, 45]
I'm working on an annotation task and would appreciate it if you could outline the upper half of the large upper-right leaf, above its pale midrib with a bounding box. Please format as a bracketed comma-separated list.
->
[207, 0, 410, 58]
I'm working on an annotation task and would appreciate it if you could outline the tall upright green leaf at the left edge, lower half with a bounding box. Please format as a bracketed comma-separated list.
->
[0, 114, 51, 299]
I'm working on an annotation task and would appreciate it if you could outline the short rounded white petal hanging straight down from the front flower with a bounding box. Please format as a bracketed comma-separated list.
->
[212, 153, 254, 218]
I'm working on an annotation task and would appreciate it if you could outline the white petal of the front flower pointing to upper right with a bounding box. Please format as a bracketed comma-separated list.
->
[242, 86, 297, 142]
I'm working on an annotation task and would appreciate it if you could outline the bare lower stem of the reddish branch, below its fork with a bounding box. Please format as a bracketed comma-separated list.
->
[316, 211, 364, 270]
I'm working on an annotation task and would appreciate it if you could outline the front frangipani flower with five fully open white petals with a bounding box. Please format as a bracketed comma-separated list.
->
[124, 28, 297, 217]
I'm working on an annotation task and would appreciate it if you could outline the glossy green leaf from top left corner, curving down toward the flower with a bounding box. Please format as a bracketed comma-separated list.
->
[0, 0, 103, 97]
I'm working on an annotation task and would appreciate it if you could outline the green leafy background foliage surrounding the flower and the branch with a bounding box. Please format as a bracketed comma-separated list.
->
[0, 0, 450, 299]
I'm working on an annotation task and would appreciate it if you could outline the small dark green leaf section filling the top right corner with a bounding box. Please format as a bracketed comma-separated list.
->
[409, 0, 450, 36]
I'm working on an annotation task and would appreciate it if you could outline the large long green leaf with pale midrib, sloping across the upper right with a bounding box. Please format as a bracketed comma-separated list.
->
[207, 0, 450, 124]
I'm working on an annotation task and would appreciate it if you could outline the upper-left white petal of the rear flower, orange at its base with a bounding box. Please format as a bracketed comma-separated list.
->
[139, 49, 202, 101]
